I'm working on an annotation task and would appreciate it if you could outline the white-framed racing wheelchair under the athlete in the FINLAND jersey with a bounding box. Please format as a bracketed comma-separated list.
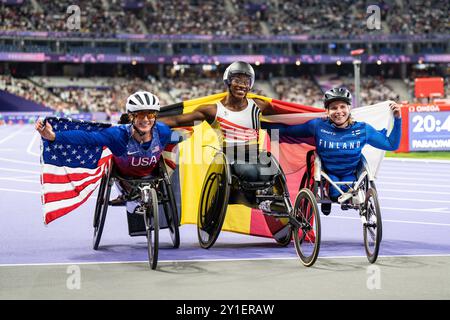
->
[300, 150, 383, 263]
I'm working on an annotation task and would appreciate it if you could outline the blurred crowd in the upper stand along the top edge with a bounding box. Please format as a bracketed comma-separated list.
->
[0, 0, 449, 37]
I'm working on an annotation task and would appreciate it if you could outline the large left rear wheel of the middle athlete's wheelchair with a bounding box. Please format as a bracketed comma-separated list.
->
[197, 152, 231, 249]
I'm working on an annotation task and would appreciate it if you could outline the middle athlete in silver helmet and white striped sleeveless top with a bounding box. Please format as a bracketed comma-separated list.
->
[160, 61, 284, 211]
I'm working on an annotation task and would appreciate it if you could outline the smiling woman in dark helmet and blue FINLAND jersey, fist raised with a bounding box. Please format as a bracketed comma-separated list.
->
[263, 88, 401, 211]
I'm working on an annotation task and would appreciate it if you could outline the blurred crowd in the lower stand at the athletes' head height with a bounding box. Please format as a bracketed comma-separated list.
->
[0, 76, 406, 113]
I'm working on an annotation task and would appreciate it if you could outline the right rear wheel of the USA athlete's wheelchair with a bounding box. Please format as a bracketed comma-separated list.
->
[161, 174, 180, 248]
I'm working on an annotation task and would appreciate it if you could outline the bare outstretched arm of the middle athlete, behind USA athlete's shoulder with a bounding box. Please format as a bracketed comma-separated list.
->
[158, 104, 216, 128]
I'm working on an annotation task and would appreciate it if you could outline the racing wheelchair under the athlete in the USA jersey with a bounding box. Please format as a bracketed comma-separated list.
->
[93, 156, 180, 269]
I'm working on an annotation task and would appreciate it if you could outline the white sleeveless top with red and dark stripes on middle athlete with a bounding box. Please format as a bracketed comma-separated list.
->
[211, 99, 261, 147]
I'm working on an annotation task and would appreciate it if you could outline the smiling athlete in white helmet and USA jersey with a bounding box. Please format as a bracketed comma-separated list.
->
[35, 91, 178, 212]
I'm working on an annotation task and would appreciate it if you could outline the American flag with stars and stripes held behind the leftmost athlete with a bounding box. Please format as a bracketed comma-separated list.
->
[41, 117, 112, 224]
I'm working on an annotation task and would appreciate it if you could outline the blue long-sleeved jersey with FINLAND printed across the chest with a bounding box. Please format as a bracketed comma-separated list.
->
[264, 118, 401, 177]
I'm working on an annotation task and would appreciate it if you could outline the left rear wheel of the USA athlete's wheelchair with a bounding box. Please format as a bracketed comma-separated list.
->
[92, 168, 112, 250]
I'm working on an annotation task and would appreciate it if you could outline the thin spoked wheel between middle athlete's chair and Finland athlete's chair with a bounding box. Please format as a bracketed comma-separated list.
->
[293, 188, 321, 267]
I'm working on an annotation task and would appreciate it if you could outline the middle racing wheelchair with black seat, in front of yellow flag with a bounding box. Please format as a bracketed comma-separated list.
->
[197, 146, 320, 267]
